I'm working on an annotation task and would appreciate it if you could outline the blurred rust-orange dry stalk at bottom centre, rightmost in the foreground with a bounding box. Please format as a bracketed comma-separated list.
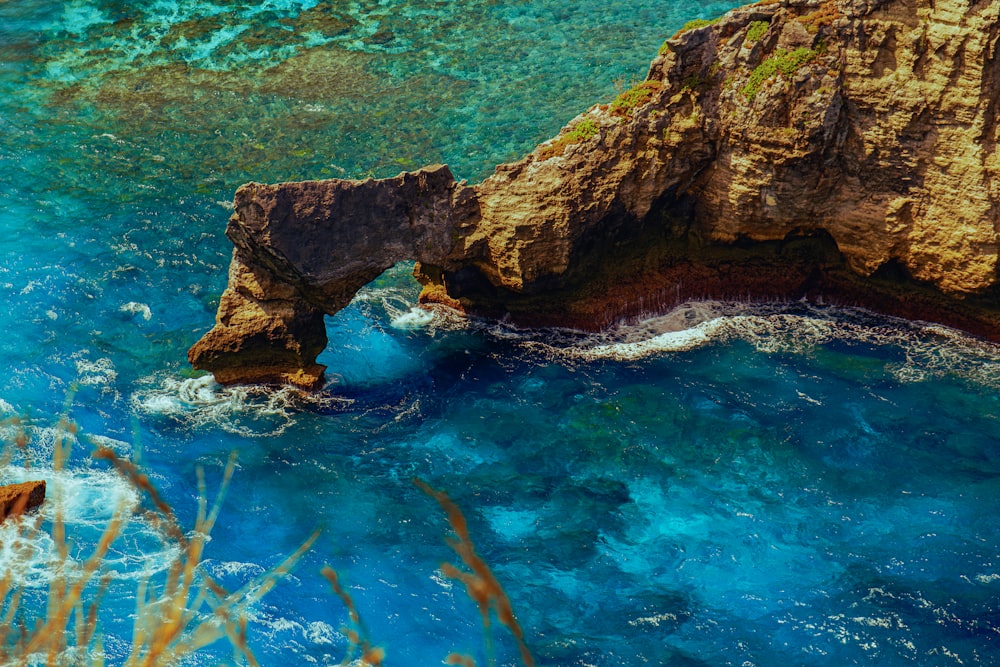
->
[413, 479, 535, 667]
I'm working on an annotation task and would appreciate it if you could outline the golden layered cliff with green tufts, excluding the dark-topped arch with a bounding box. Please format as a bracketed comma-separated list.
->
[434, 0, 1000, 328]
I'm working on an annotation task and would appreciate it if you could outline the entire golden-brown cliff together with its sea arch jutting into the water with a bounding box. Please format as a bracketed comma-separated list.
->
[189, 0, 1000, 387]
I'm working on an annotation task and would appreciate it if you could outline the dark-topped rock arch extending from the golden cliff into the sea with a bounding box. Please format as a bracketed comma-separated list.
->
[188, 166, 475, 389]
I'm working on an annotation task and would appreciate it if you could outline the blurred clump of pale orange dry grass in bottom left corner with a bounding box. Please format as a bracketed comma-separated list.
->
[0, 419, 316, 667]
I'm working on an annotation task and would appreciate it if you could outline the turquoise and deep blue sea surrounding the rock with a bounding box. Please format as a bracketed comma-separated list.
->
[0, 0, 1000, 666]
